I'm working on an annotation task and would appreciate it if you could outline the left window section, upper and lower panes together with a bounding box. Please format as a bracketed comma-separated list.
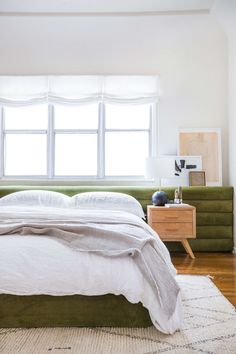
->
[2, 105, 48, 176]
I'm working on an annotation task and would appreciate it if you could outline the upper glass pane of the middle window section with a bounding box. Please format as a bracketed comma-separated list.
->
[55, 103, 98, 129]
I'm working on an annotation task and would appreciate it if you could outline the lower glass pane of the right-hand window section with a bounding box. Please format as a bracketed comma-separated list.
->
[105, 132, 149, 176]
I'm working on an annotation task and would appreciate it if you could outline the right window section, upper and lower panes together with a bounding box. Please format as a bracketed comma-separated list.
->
[105, 104, 151, 176]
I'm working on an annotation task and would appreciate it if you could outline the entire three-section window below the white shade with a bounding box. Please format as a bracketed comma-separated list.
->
[1, 102, 154, 179]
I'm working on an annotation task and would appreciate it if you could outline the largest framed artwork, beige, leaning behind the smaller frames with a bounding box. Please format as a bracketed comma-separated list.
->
[178, 128, 222, 186]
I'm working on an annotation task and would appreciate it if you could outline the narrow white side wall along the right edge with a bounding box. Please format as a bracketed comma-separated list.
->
[212, 0, 236, 249]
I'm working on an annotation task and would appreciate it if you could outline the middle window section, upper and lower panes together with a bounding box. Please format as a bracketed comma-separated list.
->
[52, 104, 99, 177]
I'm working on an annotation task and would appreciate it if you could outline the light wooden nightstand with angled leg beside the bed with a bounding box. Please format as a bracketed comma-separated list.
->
[147, 205, 196, 258]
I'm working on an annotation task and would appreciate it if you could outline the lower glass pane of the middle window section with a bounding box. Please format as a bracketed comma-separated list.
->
[55, 134, 97, 176]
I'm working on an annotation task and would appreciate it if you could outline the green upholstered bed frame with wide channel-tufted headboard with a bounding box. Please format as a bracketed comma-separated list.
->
[0, 186, 233, 327]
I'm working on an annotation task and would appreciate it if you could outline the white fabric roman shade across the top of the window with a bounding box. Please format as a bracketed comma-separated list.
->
[0, 75, 160, 105]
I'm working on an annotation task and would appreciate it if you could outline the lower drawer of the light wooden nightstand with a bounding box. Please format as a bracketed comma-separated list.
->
[152, 222, 194, 237]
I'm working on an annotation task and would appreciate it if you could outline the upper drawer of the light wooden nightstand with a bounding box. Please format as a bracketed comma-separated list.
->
[152, 209, 193, 223]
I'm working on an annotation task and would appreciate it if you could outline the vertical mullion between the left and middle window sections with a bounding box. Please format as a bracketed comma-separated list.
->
[47, 104, 55, 178]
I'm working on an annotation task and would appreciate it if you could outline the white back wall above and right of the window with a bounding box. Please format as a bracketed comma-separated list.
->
[0, 14, 228, 183]
